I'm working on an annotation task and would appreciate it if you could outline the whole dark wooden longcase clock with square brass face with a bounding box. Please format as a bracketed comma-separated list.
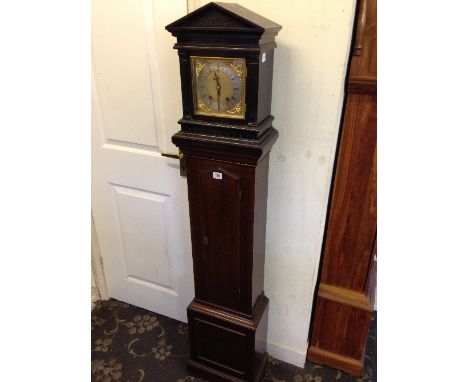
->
[166, 3, 281, 381]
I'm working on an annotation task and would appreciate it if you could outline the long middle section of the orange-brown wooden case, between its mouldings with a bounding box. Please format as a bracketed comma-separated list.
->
[322, 94, 377, 291]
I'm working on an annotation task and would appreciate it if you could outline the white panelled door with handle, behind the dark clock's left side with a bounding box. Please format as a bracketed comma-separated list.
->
[92, 0, 194, 322]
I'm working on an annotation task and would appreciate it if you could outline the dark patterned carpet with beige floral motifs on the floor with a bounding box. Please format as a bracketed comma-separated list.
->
[91, 300, 377, 382]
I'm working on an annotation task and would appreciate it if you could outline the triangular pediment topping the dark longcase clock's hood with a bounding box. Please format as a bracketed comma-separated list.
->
[166, 3, 281, 34]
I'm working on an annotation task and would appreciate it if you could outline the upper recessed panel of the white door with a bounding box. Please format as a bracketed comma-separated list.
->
[92, 0, 158, 147]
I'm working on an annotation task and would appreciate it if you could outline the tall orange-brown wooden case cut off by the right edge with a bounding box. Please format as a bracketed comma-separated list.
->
[308, 0, 377, 374]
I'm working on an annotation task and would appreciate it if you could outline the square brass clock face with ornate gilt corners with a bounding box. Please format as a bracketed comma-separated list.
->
[190, 57, 246, 119]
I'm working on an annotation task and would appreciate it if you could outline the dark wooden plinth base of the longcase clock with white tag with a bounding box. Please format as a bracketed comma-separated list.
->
[187, 294, 268, 382]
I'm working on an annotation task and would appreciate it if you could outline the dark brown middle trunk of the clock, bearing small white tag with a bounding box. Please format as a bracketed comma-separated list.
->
[187, 155, 268, 316]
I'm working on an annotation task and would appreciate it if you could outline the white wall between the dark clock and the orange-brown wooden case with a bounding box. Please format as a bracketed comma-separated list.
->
[197, 0, 355, 366]
